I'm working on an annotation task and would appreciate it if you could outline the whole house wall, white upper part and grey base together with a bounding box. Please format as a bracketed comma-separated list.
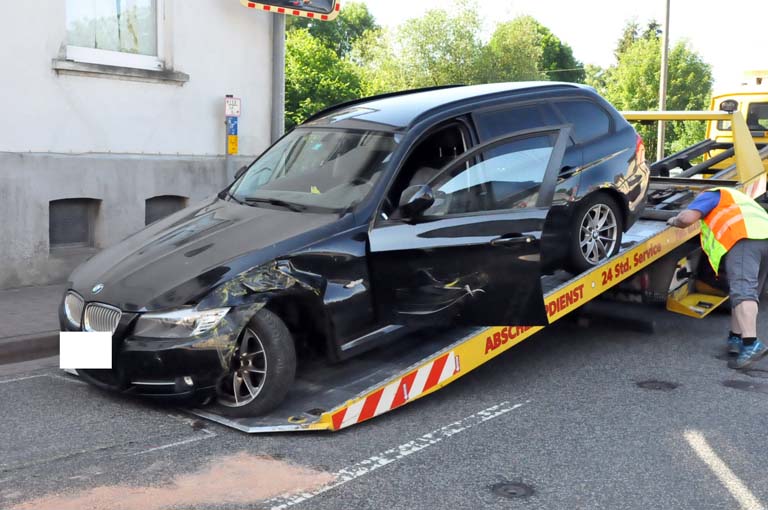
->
[0, 0, 272, 288]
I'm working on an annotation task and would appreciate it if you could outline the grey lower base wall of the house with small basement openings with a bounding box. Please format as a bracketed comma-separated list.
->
[0, 154, 252, 288]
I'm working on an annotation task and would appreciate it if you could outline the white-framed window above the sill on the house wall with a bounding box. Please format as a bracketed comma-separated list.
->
[66, 0, 164, 70]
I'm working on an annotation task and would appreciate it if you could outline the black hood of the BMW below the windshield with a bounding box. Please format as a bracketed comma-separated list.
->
[70, 198, 340, 311]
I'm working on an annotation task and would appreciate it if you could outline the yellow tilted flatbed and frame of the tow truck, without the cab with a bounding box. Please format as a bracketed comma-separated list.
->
[178, 111, 768, 433]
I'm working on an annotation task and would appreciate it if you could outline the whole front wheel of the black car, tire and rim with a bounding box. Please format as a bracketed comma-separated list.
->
[216, 309, 296, 417]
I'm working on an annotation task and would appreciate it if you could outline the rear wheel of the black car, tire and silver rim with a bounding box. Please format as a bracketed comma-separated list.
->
[568, 192, 624, 274]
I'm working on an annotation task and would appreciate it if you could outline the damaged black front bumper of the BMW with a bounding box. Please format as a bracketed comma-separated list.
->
[59, 296, 252, 398]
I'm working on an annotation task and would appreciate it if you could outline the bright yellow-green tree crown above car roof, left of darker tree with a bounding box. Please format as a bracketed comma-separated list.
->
[478, 16, 547, 83]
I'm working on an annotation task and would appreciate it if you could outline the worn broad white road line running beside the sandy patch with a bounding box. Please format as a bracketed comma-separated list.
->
[265, 400, 530, 510]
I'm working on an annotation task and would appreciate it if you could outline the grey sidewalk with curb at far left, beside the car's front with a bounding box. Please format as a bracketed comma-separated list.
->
[0, 284, 64, 364]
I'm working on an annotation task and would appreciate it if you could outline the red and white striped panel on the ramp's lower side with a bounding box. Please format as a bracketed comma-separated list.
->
[332, 351, 461, 430]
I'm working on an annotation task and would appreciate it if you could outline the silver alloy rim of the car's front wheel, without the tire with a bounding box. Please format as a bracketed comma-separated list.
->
[218, 328, 267, 407]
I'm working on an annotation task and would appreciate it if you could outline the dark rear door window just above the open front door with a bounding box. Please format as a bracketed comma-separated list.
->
[475, 104, 560, 142]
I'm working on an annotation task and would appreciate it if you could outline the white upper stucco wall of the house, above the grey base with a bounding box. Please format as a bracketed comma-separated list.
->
[0, 0, 272, 155]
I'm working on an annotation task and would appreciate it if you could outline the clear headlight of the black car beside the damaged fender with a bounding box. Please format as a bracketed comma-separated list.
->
[133, 308, 229, 338]
